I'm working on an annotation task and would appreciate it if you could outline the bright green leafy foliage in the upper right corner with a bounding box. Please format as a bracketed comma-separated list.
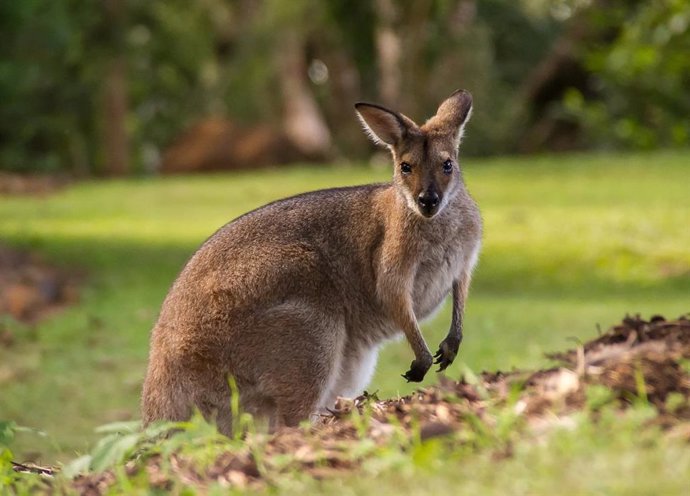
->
[564, 0, 690, 149]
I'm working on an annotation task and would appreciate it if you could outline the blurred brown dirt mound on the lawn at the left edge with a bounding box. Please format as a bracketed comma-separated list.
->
[0, 245, 78, 330]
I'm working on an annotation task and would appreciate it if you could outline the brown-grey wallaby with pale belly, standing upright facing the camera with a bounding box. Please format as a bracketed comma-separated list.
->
[142, 90, 482, 434]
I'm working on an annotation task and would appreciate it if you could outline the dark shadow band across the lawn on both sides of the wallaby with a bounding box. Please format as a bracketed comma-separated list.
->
[10, 233, 690, 310]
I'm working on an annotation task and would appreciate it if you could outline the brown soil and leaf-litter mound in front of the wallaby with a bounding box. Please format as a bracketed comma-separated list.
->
[63, 316, 690, 495]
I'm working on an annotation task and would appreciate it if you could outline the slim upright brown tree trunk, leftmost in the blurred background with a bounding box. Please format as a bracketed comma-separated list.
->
[103, 0, 130, 176]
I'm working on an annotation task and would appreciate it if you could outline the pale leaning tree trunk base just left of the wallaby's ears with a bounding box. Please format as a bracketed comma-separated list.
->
[276, 31, 331, 158]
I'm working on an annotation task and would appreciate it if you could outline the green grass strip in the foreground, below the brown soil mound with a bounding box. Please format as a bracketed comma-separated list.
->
[10, 386, 690, 496]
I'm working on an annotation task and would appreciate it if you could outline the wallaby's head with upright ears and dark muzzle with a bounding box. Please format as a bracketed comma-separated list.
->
[355, 90, 472, 218]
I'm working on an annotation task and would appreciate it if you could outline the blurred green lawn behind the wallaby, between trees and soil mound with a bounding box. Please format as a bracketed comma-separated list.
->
[0, 152, 690, 466]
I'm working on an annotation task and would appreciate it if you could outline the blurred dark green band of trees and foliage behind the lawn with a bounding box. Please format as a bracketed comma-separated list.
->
[0, 0, 690, 175]
